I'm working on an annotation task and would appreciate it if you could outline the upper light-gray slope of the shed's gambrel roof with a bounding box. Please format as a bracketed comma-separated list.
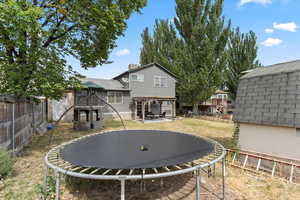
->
[241, 60, 300, 79]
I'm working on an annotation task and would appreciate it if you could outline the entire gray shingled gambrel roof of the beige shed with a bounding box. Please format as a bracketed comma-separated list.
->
[234, 60, 300, 128]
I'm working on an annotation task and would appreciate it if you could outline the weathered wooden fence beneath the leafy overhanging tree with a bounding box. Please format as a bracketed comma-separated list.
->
[0, 98, 46, 153]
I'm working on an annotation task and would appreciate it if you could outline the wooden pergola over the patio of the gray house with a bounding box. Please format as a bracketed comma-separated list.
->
[133, 97, 176, 122]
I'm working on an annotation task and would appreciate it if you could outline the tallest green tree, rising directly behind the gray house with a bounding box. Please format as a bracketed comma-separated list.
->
[140, 0, 230, 113]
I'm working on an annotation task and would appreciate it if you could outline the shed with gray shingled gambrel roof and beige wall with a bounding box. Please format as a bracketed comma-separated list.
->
[234, 60, 300, 160]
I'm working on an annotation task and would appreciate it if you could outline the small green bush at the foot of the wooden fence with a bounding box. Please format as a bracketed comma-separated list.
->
[0, 149, 14, 178]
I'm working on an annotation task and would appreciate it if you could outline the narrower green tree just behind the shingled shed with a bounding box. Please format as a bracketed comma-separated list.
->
[225, 28, 261, 101]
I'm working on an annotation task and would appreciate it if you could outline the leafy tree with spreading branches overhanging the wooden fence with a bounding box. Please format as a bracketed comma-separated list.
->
[0, 0, 146, 98]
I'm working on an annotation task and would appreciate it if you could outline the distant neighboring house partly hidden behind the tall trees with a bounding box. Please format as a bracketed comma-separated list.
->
[199, 90, 232, 115]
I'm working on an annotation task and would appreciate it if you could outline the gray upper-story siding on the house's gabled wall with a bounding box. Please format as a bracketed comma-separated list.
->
[129, 65, 176, 97]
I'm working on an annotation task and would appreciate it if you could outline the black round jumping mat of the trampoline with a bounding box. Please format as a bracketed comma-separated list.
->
[61, 130, 214, 169]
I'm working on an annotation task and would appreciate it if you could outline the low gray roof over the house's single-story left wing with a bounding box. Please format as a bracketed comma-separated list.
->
[82, 78, 128, 91]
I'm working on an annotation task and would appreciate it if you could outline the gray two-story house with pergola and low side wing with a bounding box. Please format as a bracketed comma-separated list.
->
[51, 63, 176, 122]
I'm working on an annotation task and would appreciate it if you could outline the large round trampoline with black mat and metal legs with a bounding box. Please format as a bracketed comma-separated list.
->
[44, 130, 226, 200]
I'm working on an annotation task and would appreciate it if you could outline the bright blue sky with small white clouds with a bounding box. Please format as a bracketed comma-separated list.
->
[67, 0, 300, 79]
